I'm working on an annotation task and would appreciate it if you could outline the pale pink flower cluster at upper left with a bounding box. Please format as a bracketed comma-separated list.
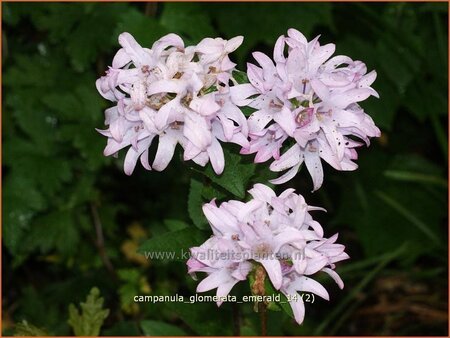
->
[96, 33, 248, 175]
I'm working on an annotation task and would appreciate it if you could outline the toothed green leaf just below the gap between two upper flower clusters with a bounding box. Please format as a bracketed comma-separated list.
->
[196, 149, 255, 199]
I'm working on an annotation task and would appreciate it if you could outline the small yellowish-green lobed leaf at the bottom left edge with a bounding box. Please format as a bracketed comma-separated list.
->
[68, 287, 109, 336]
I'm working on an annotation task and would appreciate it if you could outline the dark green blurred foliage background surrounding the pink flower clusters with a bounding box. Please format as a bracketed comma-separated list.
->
[2, 3, 448, 335]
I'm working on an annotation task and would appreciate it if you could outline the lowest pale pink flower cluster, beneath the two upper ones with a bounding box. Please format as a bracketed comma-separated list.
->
[187, 184, 349, 324]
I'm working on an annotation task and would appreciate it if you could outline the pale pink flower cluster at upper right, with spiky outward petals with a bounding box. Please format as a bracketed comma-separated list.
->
[231, 29, 380, 190]
